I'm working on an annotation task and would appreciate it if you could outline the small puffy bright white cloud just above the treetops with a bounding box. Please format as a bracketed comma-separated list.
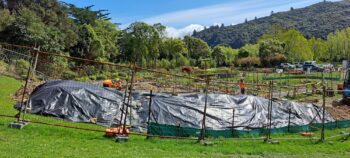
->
[165, 24, 204, 38]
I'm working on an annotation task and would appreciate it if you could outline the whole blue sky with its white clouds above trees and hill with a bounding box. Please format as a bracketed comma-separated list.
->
[62, 0, 338, 37]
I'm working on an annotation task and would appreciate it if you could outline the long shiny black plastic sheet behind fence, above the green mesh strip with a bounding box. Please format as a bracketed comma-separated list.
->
[137, 94, 334, 130]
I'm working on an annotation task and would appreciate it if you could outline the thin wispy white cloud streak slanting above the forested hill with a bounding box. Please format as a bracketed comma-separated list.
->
[141, 0, 338, 28]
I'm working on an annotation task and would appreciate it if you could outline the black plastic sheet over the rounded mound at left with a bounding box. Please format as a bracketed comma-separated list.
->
[22, 81, 123, 126]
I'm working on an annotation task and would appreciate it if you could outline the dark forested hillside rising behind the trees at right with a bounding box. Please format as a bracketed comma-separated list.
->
[193, 0, 350, 48]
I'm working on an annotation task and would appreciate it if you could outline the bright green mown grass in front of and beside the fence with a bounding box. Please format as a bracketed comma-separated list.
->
[0, 76, 350, 158]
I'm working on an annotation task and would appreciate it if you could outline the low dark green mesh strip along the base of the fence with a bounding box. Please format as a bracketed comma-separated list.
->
[148, 120, 350, 138]
